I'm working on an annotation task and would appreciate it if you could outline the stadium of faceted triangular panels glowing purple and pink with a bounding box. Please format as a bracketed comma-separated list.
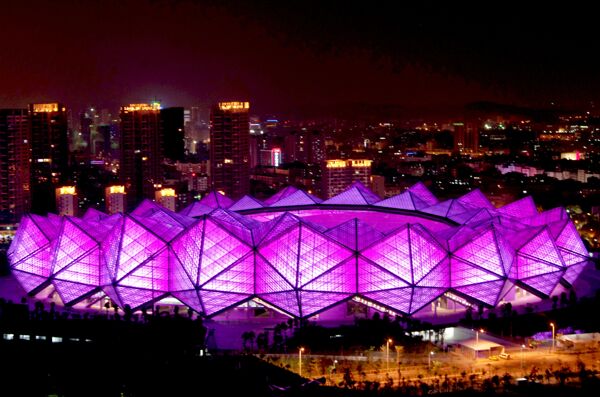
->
[8, 183, 589, 318]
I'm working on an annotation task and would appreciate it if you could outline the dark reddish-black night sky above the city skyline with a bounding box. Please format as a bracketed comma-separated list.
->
[0, 0, 600, 115]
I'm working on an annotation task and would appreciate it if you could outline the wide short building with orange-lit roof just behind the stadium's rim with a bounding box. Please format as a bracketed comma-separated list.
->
[321, 160, 373, 198]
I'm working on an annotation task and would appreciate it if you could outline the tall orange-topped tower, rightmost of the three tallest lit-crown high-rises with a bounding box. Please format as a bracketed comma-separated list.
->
[210, 102, 250, 198]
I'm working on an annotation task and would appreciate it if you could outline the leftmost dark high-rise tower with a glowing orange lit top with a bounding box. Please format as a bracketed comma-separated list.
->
[29, 103, 69, 213]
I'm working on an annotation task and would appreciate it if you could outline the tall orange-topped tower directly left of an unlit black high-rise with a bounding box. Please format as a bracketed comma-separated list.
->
[119, 102, 163, 208]
